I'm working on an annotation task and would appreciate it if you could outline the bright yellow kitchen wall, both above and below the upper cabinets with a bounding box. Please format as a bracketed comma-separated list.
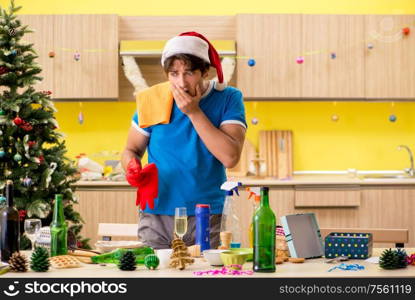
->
[0, 0, 415, 170]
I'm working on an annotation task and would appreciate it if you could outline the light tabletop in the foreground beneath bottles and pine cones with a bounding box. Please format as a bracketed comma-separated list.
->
[1, 248, 415, 278]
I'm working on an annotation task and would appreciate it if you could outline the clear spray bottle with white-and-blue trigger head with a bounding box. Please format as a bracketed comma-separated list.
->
[220, 181, 242, 248]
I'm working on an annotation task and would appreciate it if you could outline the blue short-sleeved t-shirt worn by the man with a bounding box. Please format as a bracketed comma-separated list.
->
[132, 81, 247, 216]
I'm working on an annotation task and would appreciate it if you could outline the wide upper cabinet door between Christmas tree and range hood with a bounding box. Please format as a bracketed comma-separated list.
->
[53, 15, 118, 100]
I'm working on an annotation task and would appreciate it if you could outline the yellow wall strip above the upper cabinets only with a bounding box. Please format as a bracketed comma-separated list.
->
[0, 0, 415, 16]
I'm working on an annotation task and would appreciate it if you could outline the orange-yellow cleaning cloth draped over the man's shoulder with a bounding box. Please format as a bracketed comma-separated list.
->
[136, 81, 173, 128]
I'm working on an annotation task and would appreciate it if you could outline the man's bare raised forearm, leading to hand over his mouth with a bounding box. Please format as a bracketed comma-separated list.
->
[188, 110, 242, 168]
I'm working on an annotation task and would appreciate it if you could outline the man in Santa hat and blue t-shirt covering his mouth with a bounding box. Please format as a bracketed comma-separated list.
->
[122, 32, 247, 249]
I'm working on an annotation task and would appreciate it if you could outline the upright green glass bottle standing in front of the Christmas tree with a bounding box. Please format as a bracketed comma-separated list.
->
[50, 194, 68, 256]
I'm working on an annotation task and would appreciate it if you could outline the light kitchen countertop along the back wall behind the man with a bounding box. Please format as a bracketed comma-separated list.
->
[75, 175, 415, 188]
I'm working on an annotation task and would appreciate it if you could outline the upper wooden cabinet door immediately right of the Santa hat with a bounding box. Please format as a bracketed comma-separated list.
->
[236, 14, 302, 98]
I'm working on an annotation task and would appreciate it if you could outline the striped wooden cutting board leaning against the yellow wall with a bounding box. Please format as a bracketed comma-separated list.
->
[259, 130, 293, 179]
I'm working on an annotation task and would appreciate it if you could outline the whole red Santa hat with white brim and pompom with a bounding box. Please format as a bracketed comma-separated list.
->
[161, 31, 226, 90]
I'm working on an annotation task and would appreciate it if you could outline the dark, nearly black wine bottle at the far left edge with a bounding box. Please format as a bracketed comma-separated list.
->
[0, 180, 20, 262]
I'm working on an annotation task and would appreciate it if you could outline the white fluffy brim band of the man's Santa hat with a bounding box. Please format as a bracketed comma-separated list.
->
[161, 36, 210, 66]
